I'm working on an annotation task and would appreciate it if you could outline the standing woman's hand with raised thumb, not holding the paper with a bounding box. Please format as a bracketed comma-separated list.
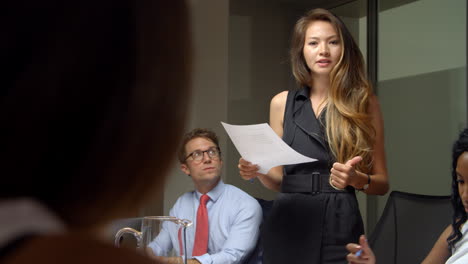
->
[330, 156, 362, 189]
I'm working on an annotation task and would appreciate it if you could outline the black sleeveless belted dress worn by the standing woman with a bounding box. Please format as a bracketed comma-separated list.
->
[262, 87, 364, 264]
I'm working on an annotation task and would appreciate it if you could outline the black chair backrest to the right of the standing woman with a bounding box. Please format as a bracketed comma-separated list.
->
[369, 191, 453, 264]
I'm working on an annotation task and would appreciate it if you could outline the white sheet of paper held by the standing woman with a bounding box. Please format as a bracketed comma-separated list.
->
[221, 122, 317, 174]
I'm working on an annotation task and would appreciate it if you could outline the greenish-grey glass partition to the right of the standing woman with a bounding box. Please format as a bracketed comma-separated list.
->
[378, 0, 467, 219]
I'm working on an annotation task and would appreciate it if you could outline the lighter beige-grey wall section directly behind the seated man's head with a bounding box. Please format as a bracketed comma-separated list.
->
[164, 0, 229, 214]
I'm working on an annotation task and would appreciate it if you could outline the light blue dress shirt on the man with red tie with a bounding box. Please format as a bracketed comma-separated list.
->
[149, 180, 262, 264]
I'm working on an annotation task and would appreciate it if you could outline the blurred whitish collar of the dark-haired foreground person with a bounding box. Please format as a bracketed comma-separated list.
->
[0, 198, 65, 248]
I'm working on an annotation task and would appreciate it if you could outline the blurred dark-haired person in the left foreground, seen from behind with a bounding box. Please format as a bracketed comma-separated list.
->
[0, 0, 191, 264]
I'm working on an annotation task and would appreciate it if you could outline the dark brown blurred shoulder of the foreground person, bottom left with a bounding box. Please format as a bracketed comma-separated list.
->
[0, 234, 154, 264]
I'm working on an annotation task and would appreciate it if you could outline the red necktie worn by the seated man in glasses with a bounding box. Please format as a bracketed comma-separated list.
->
[192, 194, 210, 256]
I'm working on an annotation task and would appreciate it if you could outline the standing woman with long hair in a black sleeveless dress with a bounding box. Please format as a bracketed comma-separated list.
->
[239, 9, 389, 264]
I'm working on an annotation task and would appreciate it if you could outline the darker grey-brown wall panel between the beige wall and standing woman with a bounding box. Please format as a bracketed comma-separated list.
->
[225, 0, 296, 200]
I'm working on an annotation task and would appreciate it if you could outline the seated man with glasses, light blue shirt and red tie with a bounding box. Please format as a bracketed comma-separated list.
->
[149, 129, 262, 264]
